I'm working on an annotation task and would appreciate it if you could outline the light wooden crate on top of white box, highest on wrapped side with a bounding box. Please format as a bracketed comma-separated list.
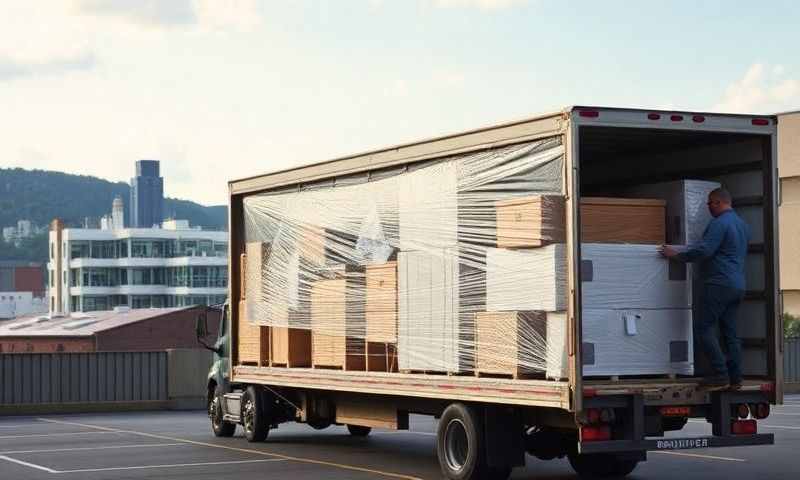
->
[495, 195, 566, 248]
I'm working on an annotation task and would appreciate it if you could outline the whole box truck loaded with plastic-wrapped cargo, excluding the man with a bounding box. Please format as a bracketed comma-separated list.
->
[198, 106, 783, 479]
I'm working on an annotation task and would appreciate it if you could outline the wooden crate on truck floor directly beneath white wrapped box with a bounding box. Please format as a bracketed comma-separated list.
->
[475, 311, 547, 378]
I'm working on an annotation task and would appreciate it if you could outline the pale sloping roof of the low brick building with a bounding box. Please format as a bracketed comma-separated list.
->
[0, 307, 194, 337]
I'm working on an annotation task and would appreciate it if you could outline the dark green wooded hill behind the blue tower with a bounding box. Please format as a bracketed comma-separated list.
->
[0, 168, 227, 230]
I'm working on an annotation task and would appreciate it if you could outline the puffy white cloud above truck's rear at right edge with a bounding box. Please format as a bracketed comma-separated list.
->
[712, 63, 800, 113]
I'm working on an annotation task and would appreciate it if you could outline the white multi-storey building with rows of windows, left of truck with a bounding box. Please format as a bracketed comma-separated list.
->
[47, 220, 228, 314]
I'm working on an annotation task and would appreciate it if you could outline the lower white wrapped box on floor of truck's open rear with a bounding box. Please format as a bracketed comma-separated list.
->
[581, 308, 694, 376]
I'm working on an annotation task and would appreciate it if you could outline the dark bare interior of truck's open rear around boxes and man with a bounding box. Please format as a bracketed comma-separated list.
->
[578, 122, 780, 388]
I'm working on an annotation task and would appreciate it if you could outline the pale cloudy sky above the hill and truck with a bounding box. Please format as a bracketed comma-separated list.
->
[0, 0, 800, 204]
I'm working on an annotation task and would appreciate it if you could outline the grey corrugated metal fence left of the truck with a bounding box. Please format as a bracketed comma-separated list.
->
[0, 352, 168, 405]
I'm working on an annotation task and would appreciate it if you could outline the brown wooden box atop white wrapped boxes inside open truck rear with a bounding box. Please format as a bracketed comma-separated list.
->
[581, 197, 666, 245]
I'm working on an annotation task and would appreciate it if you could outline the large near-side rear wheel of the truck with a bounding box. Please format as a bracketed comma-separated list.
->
[436, 403, 511, 480]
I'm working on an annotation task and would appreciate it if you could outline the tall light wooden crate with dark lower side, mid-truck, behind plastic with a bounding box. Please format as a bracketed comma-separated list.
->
[311, 273, 366, 370]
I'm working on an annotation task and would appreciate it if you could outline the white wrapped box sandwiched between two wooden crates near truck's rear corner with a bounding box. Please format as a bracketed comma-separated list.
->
[486, 243, 567, 312]
